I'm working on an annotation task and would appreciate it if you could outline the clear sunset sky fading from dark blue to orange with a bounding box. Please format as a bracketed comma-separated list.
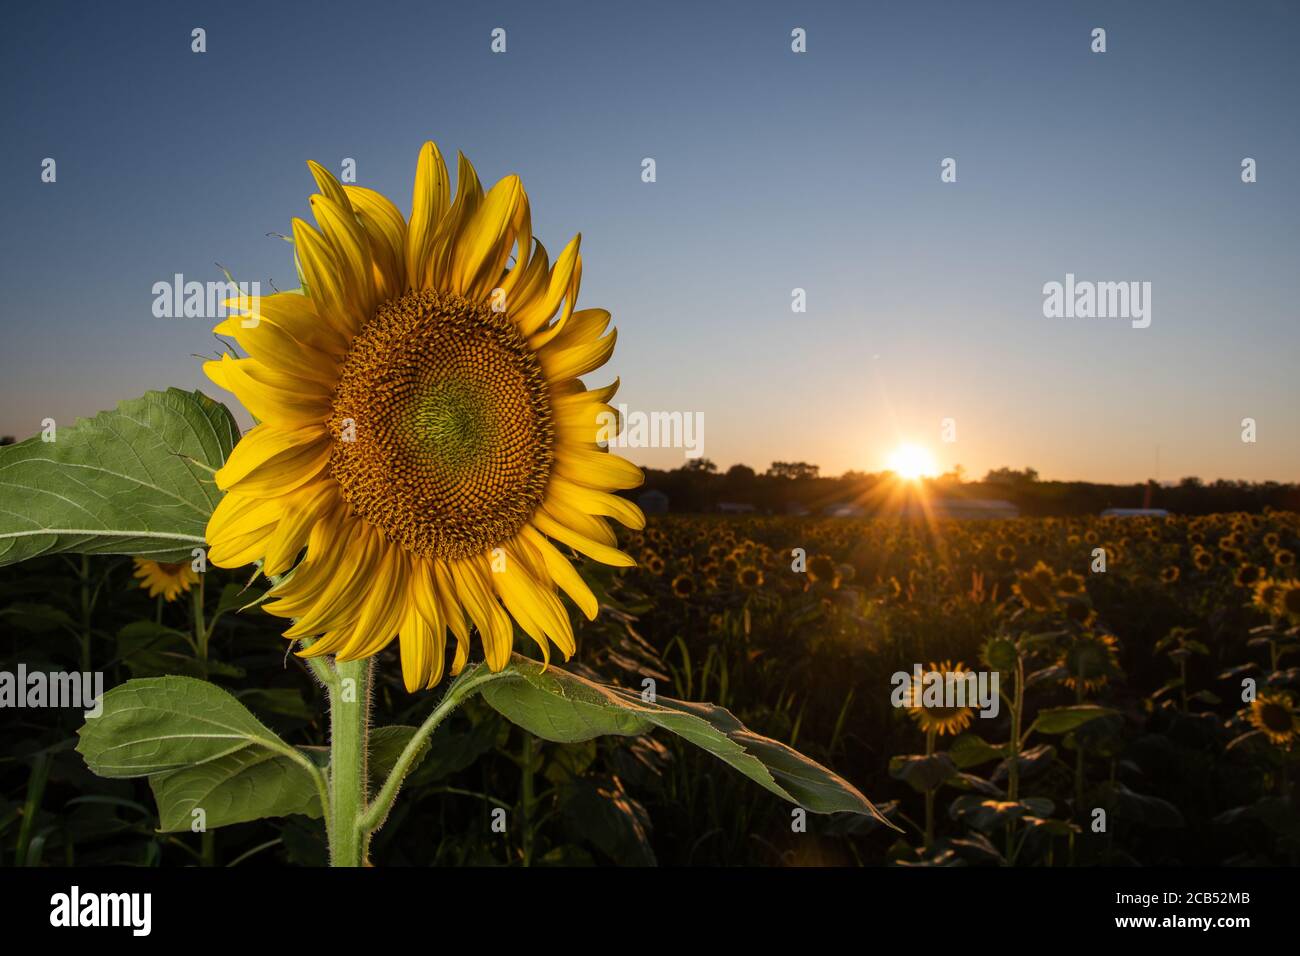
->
[0, 0, 1300, 481]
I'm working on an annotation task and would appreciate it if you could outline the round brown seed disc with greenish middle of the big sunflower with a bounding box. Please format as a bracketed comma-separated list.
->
[329, 290, 555, 559]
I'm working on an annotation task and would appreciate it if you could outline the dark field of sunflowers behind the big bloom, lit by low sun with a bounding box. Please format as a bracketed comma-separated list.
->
[0, 512, 1300, 866]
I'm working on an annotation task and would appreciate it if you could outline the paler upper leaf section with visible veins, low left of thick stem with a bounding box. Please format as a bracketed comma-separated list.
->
[77, 676, 297, 777]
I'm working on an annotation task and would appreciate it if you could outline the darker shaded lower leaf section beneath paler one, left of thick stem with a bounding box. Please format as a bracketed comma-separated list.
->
[150, 747, 321, 832]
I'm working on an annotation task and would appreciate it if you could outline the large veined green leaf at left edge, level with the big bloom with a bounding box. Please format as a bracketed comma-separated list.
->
[0, 389, 239, 566]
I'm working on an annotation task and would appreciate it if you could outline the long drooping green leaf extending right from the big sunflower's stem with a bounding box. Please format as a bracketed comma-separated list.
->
[481, 654, 893, 826]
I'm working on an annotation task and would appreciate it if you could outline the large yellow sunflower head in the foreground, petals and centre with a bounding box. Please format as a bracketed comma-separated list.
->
[204, 143, 645, 691]
